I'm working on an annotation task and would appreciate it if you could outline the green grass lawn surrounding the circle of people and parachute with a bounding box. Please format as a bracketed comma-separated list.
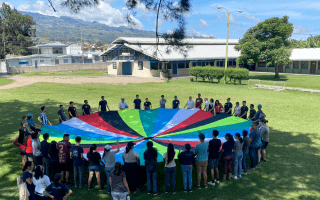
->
[0, 75, 320, 200]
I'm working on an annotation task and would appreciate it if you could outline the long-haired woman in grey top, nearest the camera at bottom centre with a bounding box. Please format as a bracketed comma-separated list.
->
[109, 162, 130, 200]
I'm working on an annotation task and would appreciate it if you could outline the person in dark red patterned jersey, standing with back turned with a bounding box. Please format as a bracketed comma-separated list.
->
[58, 134, 72, 185]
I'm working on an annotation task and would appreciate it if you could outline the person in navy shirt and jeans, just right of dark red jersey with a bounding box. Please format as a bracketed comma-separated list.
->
[70, 136, 84, 188]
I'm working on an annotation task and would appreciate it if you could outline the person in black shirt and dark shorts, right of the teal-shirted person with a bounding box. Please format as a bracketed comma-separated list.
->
[208, 130, 221, 186]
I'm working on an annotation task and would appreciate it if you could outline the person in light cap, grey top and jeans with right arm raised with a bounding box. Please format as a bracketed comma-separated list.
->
[102, 141, 120, 193]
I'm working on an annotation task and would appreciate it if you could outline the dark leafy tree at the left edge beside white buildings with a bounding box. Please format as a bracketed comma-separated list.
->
[0, 3, 36, 59]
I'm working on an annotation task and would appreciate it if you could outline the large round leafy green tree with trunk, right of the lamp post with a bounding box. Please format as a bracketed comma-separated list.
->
[235, 16, 293, 78]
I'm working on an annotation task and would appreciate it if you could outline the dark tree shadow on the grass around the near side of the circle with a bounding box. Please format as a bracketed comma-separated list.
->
[0, 100, 320, 200]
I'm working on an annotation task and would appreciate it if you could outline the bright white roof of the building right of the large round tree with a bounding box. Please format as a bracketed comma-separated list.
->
[289, 48, 320, 61]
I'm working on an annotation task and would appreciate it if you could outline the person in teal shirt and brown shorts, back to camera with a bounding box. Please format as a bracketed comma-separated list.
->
[195, 131, 208, 189]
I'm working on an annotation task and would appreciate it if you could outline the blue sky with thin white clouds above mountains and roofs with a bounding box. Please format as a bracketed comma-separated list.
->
[0, 0, 320, 40]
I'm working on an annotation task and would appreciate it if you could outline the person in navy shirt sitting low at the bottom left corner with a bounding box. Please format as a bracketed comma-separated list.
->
[43, 173, 72, 200]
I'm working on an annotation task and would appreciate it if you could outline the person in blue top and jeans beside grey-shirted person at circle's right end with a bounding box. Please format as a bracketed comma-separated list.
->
[249, 122, 260, 170]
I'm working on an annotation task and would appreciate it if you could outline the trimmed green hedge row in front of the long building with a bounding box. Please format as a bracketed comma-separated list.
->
[189, 66, 249, 84]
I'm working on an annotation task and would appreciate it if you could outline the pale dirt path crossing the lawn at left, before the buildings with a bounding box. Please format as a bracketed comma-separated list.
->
[0, 76, 164, 90]
